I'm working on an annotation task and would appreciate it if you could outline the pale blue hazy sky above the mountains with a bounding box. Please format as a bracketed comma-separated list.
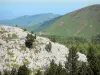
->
[0, 0, 100, 19]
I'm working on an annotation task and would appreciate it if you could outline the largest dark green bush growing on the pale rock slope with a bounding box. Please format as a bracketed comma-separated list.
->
[25, 34, 36, 48]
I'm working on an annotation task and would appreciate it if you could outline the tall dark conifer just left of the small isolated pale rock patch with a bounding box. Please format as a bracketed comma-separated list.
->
[65, 47, 78, 75]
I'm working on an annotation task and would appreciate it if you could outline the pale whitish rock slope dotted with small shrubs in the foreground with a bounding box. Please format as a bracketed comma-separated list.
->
[0, 26, 87, 70]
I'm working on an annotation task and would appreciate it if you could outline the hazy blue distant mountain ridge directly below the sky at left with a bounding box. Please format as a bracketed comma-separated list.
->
[0, 13, 59, 27]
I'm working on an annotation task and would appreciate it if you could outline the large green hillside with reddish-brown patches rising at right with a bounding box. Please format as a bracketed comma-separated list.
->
[44, 4, 100, 36]
